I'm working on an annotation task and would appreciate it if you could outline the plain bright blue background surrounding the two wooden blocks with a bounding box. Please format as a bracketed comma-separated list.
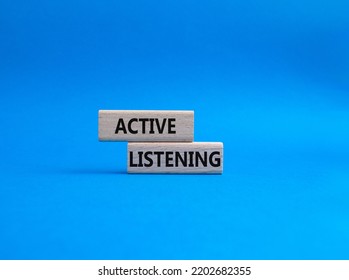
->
[0, 0, 349, 259]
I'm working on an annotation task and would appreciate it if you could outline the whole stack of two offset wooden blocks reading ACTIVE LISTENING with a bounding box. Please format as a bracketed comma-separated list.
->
[98, 110, 223, 174]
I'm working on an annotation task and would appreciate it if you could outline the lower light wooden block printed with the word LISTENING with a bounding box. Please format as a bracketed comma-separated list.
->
[127, 142, 223, 174]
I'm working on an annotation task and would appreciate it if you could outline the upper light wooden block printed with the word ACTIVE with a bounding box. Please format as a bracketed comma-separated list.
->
[98, 110, 194, 142]
